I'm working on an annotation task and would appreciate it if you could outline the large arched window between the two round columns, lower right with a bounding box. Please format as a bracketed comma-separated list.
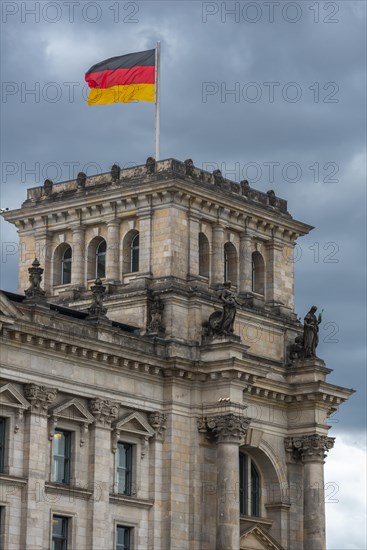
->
[239, 453, 260, 517]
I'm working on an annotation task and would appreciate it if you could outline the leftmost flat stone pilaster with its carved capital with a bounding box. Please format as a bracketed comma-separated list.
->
[21, 384, 57, 550]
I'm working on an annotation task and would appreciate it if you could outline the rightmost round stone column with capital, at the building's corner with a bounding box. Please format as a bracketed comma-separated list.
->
[289, 435, 334, 550]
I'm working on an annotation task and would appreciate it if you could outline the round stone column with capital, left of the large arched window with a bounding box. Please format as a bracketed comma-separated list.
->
[207, 413, 250, 550]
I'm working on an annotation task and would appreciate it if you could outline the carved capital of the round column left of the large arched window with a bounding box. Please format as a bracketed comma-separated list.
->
[204, 413, 250, 445]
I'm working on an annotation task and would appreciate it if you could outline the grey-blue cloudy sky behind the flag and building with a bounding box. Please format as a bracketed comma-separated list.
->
[1, 0, 367, 550]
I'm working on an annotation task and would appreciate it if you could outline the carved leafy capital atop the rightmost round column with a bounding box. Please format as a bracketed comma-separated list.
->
[284, 434, 335, 463]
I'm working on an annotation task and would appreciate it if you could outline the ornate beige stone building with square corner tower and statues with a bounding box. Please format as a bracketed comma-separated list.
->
[0, 158, 352, 550]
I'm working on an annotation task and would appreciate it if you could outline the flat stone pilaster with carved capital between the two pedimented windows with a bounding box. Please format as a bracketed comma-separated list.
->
[86, 398, 120, 550]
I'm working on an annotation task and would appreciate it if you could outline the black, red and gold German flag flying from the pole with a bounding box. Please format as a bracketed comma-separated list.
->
[85, 49, 155, 105]
